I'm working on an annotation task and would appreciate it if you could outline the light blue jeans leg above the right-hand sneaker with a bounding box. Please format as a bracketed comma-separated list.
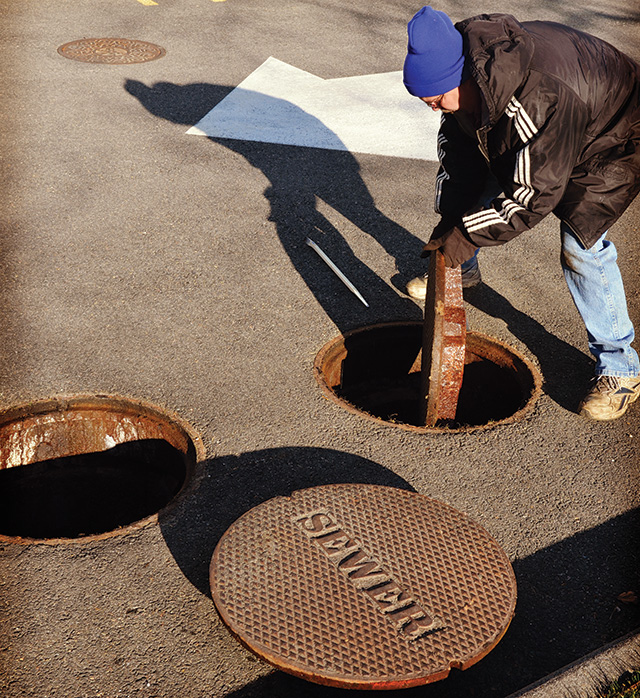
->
[560, 223, 640, 378]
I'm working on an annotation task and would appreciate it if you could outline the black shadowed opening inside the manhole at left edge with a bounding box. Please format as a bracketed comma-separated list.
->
[0, 439, 187, 538]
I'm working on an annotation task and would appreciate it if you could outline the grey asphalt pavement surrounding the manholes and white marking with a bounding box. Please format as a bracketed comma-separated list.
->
[0, 0, 640, 698]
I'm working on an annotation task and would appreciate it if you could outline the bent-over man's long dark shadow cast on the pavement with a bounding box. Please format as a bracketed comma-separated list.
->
[125, 80, 425, 331]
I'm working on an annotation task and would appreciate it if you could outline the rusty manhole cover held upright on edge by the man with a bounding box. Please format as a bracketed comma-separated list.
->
[419, 250, 467, 427]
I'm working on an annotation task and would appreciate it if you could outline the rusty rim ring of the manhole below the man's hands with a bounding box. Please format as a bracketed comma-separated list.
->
[313, 320, 543, 434]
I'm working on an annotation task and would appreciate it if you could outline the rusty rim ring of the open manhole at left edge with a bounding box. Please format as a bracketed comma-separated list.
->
[0, 393, 206, 545]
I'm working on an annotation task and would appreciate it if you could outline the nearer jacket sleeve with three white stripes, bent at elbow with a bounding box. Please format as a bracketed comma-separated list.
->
[462, 89, 588, 247]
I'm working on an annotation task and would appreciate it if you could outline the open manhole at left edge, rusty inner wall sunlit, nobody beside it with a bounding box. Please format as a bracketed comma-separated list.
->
[0, 395, 204, 542]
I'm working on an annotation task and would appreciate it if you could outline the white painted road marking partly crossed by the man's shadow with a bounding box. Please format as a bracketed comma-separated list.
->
[187, 58, 440, 161]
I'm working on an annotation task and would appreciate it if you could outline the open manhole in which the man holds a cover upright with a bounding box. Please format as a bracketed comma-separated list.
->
[314, 322, 542, 432]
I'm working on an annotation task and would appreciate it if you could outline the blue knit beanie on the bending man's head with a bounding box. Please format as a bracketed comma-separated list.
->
[404, 7, 464, 97]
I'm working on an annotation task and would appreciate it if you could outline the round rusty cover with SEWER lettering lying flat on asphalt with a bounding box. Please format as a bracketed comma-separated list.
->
[210, 484, 516, 689]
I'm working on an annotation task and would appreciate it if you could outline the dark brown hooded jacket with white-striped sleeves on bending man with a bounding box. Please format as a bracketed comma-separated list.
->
[436, 14, 640, 250]
